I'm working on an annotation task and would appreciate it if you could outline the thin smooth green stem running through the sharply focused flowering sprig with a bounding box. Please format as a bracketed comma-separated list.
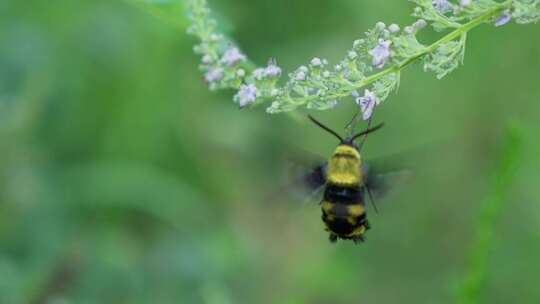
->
[301, 0, 512, 104]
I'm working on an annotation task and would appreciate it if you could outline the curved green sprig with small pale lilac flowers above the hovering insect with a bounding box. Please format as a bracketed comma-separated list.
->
[189, 0, 540, 119]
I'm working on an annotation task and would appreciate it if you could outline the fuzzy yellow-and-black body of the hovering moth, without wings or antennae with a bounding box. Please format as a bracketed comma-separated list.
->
[321, 145, 369, 241]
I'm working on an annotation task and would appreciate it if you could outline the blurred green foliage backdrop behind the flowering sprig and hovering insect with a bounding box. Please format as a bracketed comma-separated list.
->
[0, 0, 540, 304]
